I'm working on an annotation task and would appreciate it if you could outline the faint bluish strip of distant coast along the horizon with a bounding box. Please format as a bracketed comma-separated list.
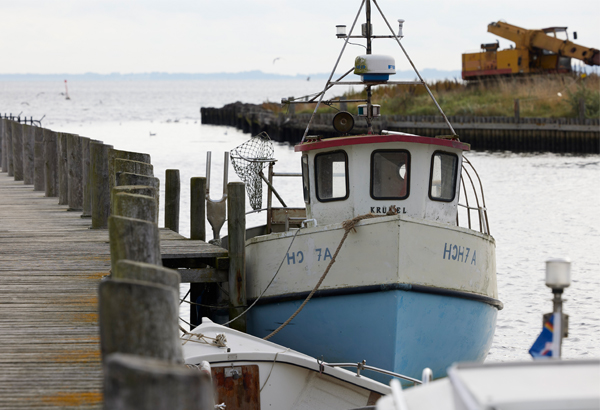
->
[0, 68, 461, 81]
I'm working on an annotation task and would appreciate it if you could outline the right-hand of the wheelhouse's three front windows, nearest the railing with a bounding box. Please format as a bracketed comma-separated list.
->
[429, 151, 458, 202]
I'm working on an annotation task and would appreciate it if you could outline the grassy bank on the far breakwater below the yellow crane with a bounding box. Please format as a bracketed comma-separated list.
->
[264, 74, 600, 118]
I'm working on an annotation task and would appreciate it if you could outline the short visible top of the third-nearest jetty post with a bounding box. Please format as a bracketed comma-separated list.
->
[111, 259, 181, 293]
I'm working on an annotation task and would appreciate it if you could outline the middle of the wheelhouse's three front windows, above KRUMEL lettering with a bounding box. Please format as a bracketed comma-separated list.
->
[371, 150, 410, 199]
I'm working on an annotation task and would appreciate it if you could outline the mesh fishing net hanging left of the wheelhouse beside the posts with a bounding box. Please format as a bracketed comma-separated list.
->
[231, 132, 274, 210]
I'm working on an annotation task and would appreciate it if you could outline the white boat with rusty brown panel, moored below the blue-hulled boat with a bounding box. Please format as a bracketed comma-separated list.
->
[182, 318, 408, 410]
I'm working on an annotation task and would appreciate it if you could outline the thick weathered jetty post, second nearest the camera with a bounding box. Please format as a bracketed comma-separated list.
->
[98, 279, 183, 363]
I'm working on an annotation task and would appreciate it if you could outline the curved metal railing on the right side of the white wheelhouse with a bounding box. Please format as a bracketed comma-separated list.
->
[456, 157, 490, 235]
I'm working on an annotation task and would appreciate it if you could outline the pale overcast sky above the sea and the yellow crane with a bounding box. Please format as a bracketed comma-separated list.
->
[0, 0, 600, 75]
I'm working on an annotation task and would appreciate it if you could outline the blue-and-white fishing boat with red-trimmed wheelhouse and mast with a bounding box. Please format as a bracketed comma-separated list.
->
[223, 0, 502, 382]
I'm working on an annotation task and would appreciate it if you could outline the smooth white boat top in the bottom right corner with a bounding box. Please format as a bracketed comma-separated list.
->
[394, 359, 600, 410]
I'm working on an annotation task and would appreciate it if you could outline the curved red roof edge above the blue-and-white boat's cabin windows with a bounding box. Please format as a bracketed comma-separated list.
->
[294, 134, 471, 152]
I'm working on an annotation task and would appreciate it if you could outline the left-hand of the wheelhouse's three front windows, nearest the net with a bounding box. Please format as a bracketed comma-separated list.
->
[315, 151, 348, 202]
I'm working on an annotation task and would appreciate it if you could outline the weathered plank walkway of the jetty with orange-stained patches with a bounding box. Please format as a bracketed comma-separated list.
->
[0, 173, 227, 409]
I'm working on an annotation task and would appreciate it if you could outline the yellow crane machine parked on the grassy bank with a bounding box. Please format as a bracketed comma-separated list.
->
[462, 21, 600, 80]
